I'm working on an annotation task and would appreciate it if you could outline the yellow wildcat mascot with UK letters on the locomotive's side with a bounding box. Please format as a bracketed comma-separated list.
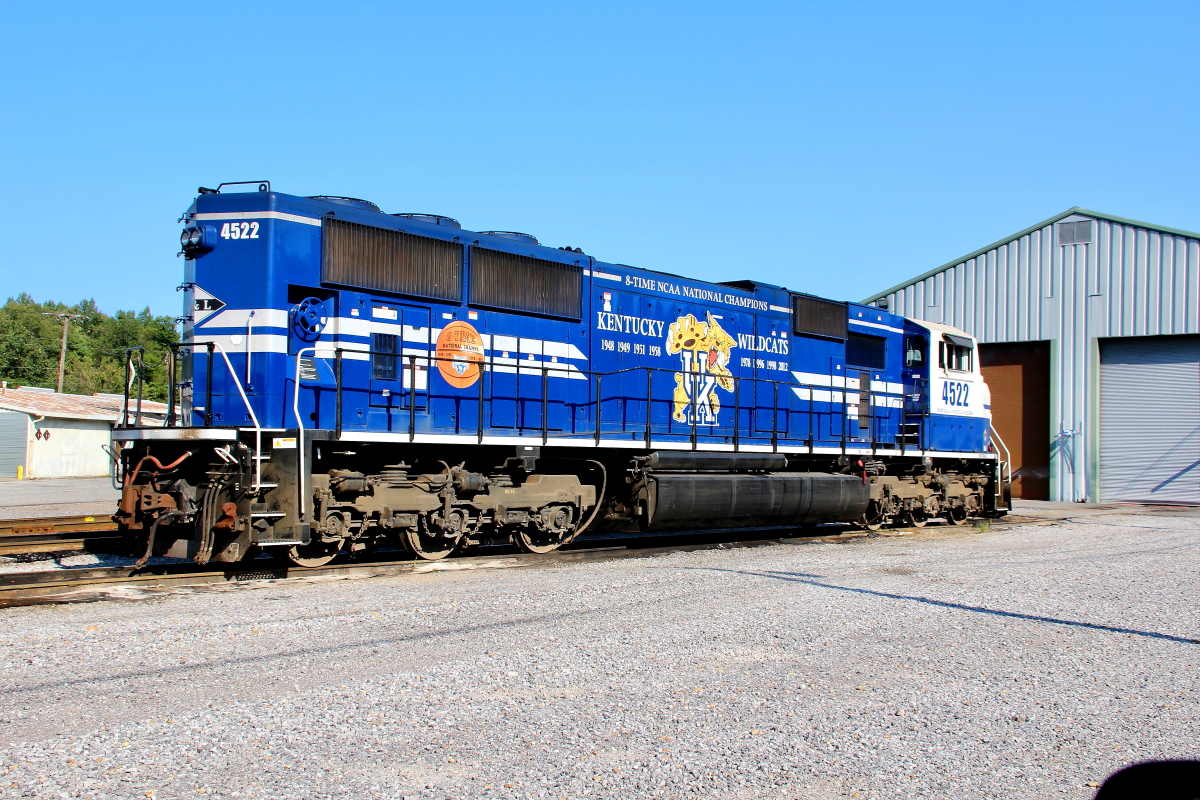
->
[667, 312, 737, 425]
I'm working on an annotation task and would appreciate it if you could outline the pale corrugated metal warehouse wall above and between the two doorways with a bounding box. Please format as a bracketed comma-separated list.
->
[884, 213, 1200, 500]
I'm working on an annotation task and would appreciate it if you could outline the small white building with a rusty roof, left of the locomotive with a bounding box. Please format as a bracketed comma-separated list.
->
[0, 386, 167, 480]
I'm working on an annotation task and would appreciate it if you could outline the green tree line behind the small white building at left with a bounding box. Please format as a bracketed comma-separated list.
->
[0, 293, 179, 401]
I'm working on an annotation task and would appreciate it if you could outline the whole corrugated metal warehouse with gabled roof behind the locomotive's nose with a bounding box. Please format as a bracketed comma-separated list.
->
[865, 207, 1200, 504]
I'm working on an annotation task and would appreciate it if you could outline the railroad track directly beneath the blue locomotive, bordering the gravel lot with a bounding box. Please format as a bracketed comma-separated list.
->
[0, 517, 1043, 608]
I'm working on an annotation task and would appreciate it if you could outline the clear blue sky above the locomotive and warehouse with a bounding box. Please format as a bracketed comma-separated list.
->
[0, 1, 1200, 314]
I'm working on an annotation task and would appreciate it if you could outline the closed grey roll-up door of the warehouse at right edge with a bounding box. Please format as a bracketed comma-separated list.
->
[1100, 336, 1200, 504]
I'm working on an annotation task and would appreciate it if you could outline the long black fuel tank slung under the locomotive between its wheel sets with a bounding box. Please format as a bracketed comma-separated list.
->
[644, 473, 870, 530]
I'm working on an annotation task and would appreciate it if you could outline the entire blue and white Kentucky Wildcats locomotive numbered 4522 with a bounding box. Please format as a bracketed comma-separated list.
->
[113, 181, 1008, 565]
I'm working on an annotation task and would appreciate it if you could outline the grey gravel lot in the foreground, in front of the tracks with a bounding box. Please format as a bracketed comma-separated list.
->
[0, 515, 1200, 800]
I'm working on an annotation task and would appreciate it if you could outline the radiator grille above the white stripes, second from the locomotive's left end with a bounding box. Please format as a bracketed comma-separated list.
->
[470, 247, 583, 319]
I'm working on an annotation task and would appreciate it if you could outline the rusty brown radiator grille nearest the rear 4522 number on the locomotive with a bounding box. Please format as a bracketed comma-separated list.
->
[320, 219, 462, 301]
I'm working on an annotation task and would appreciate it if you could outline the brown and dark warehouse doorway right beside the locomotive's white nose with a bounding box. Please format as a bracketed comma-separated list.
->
[979, 342, 1050, 500]
